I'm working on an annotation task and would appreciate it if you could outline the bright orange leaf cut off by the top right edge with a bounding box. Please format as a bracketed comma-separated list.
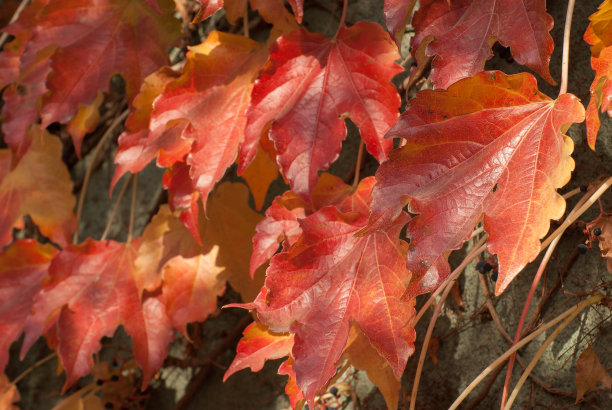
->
[584, 0, 612, 149]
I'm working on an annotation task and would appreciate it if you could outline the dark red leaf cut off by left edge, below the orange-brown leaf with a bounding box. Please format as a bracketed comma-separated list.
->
[0, 239, 57, 374]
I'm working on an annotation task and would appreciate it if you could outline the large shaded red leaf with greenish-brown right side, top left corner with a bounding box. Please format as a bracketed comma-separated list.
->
[0, 0, 180, 154]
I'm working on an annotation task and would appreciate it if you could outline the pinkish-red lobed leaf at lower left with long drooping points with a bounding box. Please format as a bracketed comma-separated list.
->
[23, 239, 173, 389]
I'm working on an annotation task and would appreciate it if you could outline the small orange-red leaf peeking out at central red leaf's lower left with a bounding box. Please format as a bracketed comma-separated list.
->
[223, 322, 293, 381]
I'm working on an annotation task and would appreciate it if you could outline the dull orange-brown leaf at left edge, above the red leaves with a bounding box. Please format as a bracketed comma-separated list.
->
[0, 127, 76, 246]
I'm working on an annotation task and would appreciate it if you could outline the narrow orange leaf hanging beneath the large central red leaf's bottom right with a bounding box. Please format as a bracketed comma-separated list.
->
[345, 326, 401, 409]
